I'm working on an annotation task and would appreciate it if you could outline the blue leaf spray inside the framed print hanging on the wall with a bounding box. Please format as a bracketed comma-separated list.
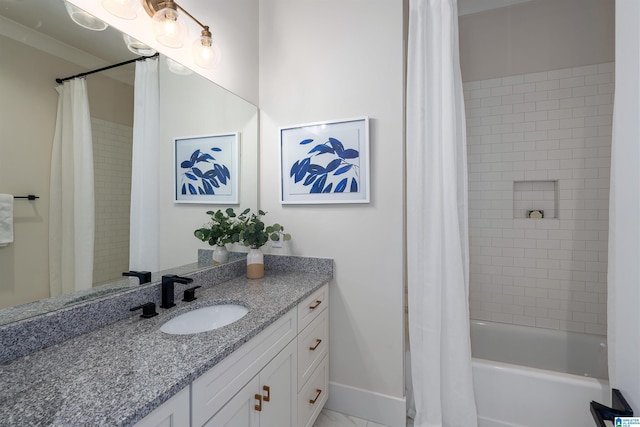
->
[289, 137, 360, 194]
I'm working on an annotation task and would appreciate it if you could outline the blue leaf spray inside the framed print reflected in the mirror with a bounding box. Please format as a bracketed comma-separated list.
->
[180, 147, 231, 195]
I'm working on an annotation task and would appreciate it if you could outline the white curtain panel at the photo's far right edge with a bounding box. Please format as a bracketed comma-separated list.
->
[608, 0, 640, 413]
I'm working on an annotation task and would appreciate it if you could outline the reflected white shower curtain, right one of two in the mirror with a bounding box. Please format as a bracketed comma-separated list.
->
[129, 58, 160, 271]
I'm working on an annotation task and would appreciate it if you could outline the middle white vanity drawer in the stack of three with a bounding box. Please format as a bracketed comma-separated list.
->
[298, 310, 329, 389]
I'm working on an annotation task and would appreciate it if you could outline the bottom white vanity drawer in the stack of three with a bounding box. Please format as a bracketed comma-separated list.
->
[298, 356, 329, 427]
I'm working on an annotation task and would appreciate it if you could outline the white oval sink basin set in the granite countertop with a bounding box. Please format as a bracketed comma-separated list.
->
[160, 304, 249, 335]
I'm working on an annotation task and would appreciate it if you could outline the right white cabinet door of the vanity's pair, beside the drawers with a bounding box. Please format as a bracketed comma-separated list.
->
[260, 340, 298, 427]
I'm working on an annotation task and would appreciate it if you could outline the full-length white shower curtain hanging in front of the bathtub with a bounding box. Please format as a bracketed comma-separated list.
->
[407, 0, 477, 427]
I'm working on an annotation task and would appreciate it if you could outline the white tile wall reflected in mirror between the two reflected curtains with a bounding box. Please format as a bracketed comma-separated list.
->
[91, 118, 133, 285]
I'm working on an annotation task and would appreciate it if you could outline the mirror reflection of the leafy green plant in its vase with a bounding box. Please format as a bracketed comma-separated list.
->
[193, 208, 242, 264]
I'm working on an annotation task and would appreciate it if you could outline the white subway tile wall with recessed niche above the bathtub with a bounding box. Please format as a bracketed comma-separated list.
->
[464, 63, 614, 334]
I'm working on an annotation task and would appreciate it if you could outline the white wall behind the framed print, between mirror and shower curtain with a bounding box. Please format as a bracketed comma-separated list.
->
[259, 0, 405, 426]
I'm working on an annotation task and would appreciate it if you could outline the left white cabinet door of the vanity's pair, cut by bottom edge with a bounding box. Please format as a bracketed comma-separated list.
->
[205, 377, 264, 427]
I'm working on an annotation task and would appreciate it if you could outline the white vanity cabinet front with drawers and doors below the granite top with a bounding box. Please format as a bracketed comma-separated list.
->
[136, 284, 329, 427]
